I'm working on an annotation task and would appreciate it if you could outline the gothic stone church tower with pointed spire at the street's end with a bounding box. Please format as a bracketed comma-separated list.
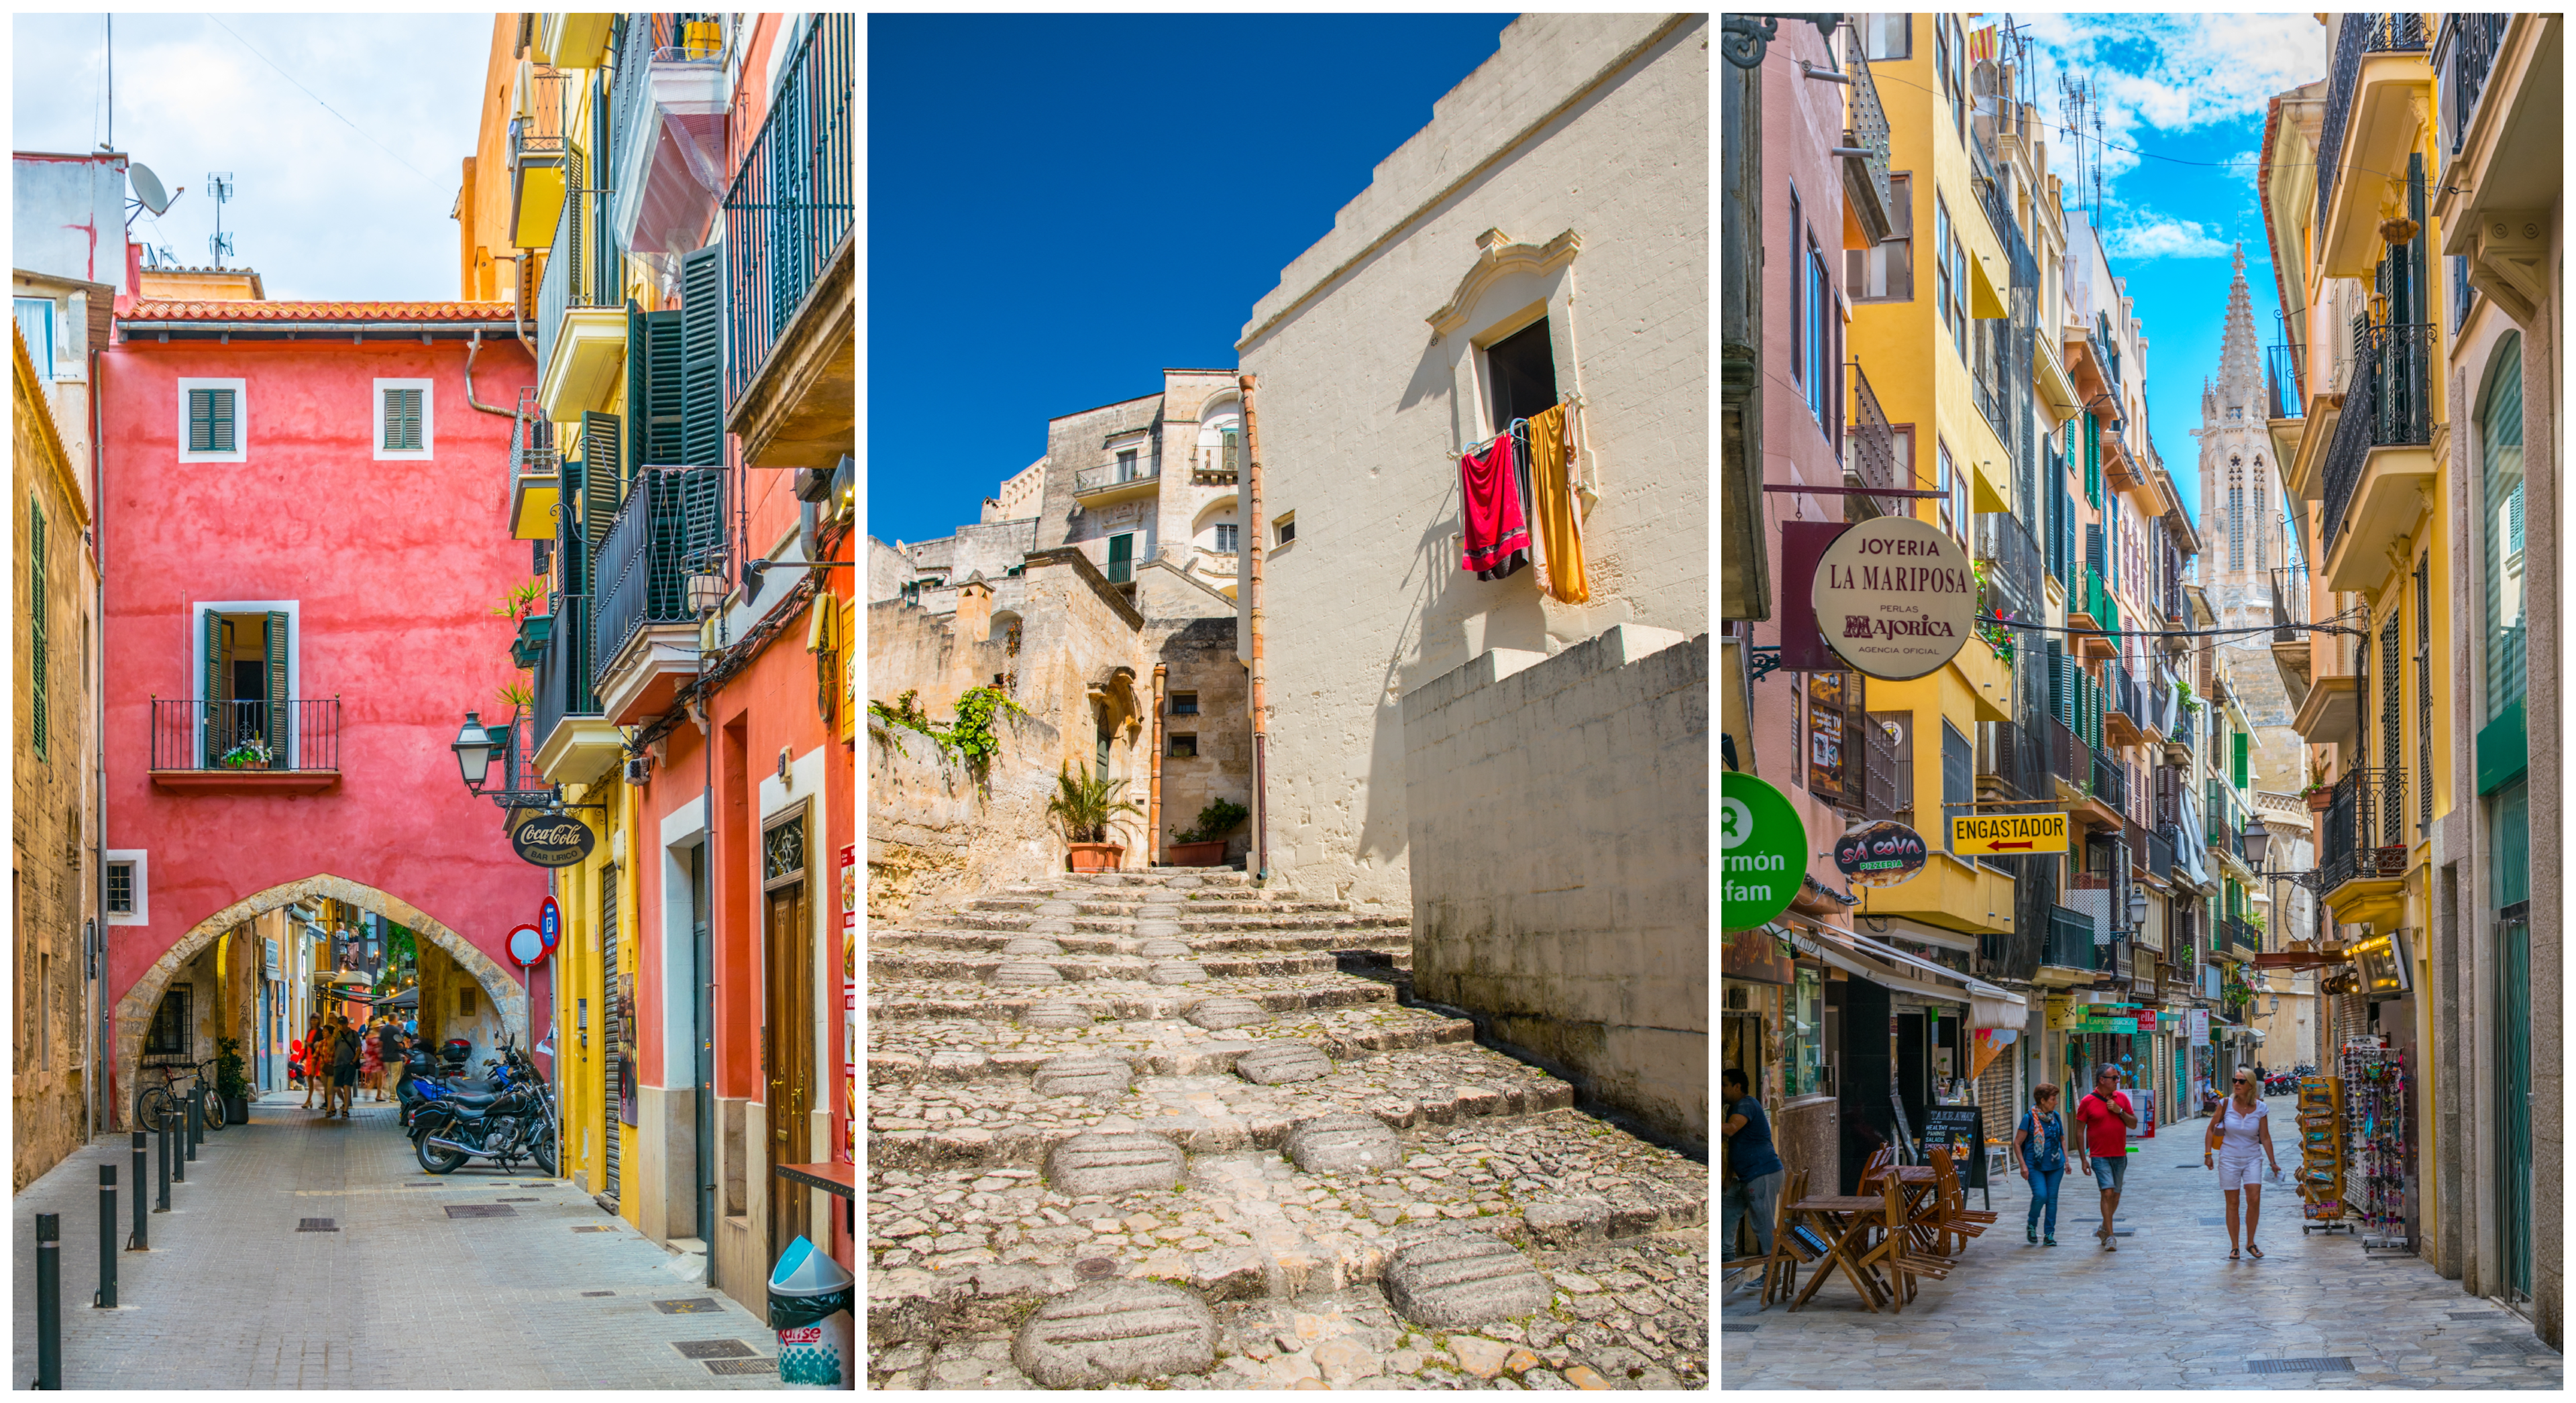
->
[2192, 245, 2308, 793]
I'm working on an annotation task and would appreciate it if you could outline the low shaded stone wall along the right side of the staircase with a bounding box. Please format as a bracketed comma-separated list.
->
[1404, 626, 1708, 1148]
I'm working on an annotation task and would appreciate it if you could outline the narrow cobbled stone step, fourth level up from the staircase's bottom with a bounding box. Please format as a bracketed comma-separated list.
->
[868, 1001, 1476, 1086]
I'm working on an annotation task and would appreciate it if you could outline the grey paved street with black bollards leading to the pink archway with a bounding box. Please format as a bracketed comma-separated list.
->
[10, 1092, 781, 1388]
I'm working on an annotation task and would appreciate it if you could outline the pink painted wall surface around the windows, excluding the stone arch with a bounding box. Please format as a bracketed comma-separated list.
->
[101, 329, 546, 999]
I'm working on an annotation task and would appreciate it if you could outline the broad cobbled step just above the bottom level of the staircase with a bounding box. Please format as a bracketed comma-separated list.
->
[868, 1109, 1708, 1378]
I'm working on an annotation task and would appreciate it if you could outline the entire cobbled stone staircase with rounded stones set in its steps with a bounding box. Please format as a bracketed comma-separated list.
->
[865, 868, 1711, 1388]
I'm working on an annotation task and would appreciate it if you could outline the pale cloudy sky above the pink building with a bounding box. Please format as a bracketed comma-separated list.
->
[10, 13, 492, 301]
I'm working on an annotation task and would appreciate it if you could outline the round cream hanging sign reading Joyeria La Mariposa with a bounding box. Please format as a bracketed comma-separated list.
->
[1813, 518, 1976, 682]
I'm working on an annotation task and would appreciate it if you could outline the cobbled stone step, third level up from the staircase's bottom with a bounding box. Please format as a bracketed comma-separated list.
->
[868, 1037, 1574, 1169]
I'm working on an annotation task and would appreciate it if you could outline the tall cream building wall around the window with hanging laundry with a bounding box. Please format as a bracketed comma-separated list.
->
[1236, 15, 1711, 903]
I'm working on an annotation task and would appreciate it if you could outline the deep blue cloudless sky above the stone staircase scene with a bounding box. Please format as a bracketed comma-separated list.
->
[868, 15, 1512, 541]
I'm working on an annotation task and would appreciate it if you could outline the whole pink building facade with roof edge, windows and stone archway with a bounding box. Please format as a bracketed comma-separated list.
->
[101, 298, 549, 1117]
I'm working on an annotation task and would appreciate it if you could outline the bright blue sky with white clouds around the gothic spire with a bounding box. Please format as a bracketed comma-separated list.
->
[2009, 13, 2326, 520]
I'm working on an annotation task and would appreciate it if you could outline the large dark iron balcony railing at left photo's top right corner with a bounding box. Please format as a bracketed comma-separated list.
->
[726, 13, 858, 404]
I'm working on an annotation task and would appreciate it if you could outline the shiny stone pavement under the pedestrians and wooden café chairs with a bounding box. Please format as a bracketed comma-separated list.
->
[1718, 1097, 2563, 1390]
